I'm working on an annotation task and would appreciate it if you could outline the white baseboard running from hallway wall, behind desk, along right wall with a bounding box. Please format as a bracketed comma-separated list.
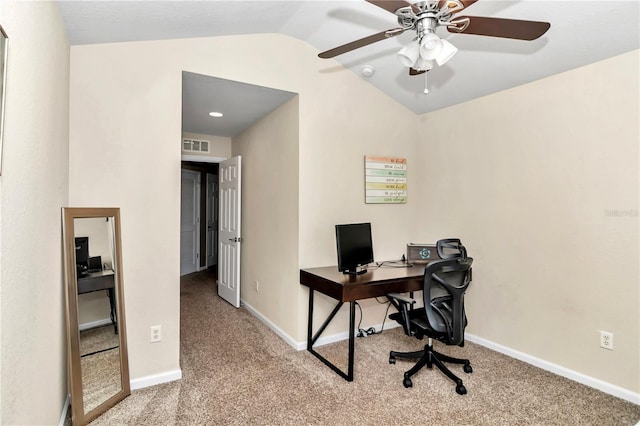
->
[243, 302, 640, 406]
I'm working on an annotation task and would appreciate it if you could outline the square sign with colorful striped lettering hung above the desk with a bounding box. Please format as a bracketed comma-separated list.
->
[364, 155, 407, 204]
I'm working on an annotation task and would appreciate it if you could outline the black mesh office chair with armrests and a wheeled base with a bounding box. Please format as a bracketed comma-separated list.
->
[388, 251, 473, 395]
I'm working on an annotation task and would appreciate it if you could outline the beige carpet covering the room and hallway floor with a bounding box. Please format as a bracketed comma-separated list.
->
[92, 273, 640, 425]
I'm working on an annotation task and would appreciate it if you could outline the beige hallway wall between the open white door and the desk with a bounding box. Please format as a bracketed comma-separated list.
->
[232, 97, 300, 336]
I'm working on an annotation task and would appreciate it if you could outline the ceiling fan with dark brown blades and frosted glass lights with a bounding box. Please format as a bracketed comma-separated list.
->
[318, 0, 551, 93]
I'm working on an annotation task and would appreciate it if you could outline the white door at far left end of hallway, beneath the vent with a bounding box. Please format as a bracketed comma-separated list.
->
[180, 170, 200, 276]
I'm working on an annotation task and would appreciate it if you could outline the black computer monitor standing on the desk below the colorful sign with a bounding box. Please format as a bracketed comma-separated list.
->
[336, 223, 373, 275]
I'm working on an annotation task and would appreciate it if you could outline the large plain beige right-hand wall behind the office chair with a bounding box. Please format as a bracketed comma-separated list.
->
[412, 51, 640, 393]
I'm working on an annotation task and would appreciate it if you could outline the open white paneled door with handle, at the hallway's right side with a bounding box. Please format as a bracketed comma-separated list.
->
[218, 156, 241, 308]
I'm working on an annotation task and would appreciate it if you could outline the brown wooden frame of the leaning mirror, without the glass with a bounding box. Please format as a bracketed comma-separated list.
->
[62, 207, 131, 425]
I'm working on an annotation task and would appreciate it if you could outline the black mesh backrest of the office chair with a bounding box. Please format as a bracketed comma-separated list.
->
[422, 257, 473, 345]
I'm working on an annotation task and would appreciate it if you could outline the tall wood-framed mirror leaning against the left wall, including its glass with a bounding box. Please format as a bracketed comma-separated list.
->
[62, 208, 131, 425]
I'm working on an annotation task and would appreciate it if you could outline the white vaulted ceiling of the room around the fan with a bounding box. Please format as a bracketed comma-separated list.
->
[58, 0, 640, 136]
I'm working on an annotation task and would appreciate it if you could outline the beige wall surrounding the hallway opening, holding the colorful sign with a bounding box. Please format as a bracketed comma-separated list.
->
[69, 34, 416, 379]
